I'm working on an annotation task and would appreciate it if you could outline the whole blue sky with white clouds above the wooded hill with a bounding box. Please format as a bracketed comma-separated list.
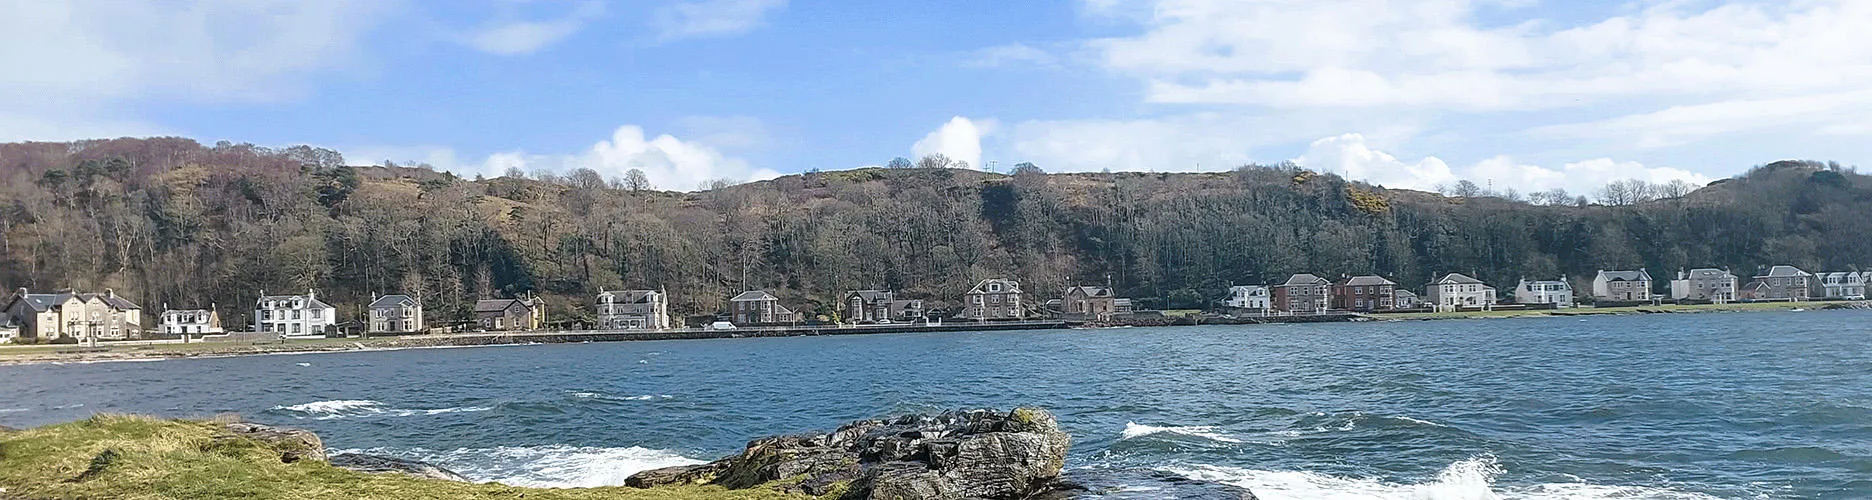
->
[0, 0, 1872, 193]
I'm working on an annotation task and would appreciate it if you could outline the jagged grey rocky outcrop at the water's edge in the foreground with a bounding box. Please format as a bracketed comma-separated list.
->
[625, 408, 1071, 500]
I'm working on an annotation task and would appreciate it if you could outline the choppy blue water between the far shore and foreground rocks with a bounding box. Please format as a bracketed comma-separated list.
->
[0, 311, 1872, 500]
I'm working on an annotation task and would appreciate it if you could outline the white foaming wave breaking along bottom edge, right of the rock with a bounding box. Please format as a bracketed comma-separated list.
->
[1164, 455, 1717, 500]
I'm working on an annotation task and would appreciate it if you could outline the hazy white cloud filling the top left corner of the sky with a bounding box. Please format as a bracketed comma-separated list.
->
[0, 0, 395, 140]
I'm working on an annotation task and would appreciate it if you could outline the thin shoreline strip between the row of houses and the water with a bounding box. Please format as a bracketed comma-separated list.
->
[0, 301, 1872, 367]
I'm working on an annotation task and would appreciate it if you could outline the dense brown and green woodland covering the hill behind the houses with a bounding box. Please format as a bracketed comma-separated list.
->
[0, 137, 1872, 324]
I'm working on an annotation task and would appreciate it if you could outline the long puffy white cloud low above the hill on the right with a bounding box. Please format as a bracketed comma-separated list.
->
[1294, 133, 1711, 195]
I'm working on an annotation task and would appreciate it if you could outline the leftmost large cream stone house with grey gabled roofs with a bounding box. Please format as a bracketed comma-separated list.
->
[6, 288, 142, 341]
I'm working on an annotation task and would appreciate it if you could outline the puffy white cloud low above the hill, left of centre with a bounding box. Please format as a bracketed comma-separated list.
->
[344, 125, 781, 191]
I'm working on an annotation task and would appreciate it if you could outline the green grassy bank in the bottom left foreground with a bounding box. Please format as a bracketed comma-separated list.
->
[0, 414, 805, 500]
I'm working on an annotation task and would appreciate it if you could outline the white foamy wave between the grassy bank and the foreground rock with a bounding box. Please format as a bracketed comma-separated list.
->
[331, 446, 702, 489]
